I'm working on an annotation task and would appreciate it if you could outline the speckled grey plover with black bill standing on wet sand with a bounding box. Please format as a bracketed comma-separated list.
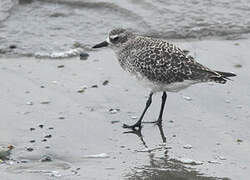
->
[93, 28, 236, 130]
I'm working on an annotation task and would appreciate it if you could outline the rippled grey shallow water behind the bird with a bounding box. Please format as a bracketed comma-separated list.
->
[0, 0, 250, 57]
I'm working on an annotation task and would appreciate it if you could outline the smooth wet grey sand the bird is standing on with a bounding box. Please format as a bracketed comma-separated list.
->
[0, 37, 250, 180]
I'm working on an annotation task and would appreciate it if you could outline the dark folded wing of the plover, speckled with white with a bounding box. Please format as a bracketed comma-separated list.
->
[131, 37, 224, 83]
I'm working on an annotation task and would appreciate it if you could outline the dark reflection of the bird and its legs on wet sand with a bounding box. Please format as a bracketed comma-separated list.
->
[124, 125, 229, 180]
